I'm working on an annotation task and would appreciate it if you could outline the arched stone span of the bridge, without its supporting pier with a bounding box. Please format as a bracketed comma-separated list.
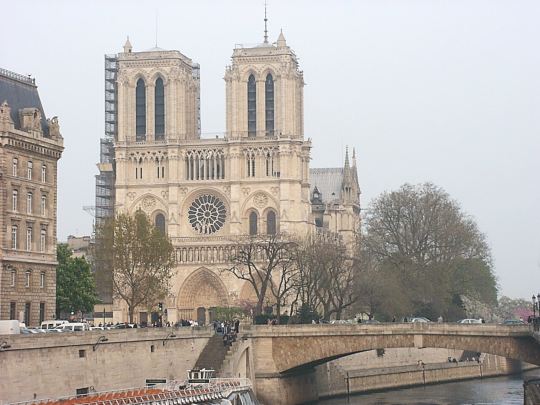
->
[249, 324, 540, 374]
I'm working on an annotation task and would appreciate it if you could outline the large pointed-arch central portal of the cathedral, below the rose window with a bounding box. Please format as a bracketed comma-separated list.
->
[176, 267, 229, 325]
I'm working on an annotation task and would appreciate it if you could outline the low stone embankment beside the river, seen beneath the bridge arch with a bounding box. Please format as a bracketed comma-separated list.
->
[316, 355, 535, 398]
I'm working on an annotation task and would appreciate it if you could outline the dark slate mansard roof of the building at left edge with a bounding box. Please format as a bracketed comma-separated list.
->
[0, 69, 49, 136]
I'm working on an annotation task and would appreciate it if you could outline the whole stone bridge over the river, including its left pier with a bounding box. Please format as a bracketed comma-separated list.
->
[237, 323, 540, 405]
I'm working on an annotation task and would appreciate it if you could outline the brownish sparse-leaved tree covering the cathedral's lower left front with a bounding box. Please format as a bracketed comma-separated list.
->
[95, 211, 174, 322]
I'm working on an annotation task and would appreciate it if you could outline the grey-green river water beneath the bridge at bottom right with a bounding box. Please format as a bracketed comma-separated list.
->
[317, 370, 540, 405]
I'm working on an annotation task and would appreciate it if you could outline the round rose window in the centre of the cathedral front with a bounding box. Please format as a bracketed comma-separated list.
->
[188, 194, 227, 235]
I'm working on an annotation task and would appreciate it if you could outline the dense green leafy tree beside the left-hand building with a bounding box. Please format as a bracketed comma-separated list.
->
[56, 243, 99, 317]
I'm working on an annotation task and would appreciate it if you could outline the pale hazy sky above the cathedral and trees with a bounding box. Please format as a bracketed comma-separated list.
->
[0, 0, 540, 297]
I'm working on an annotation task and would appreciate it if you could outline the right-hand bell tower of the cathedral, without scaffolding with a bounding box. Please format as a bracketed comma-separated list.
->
[225, 29, 304, 139]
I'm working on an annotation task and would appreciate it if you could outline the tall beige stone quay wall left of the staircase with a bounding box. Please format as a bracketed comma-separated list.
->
[0, 328, 212, 404]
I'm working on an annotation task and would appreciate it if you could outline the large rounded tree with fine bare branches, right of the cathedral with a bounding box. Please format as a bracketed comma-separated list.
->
[358, 183, 497, 319]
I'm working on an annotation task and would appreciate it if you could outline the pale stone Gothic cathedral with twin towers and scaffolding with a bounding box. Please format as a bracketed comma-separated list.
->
[101, 26, 360, 322]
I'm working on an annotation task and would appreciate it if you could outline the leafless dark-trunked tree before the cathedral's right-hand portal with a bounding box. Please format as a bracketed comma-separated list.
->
[222, 235, 295, 315]
